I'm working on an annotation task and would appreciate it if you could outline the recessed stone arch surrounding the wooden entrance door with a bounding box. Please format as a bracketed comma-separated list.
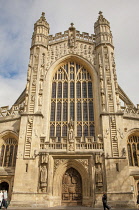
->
[53, 159, 90, 198]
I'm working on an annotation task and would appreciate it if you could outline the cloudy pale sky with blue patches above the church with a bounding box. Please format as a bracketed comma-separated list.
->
[0, 0, 139, 107]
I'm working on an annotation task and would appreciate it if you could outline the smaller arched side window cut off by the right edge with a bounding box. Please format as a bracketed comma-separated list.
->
[127, 135, 139, 166]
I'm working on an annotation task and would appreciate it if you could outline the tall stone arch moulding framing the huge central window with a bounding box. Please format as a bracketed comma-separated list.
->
[43, 55, 100, 138]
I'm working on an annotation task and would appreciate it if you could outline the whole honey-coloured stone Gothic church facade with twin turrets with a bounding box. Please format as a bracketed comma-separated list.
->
[0, 12, 139, 207]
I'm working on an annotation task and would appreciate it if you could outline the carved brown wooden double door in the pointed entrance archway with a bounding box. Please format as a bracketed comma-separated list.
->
[62, 167, 82, 206]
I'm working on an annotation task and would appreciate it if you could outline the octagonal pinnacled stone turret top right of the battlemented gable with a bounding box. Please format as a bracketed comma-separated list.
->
[94, 12, 113, 45]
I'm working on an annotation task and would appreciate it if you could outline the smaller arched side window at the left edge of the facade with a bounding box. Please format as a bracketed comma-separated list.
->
[0, 138, 17, 167]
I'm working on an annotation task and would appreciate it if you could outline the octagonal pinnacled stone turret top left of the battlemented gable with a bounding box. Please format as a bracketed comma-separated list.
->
[31, 12, 50, 47]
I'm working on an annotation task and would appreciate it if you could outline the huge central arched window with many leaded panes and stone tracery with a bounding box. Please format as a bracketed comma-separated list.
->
[50, 61, 95, 139]
